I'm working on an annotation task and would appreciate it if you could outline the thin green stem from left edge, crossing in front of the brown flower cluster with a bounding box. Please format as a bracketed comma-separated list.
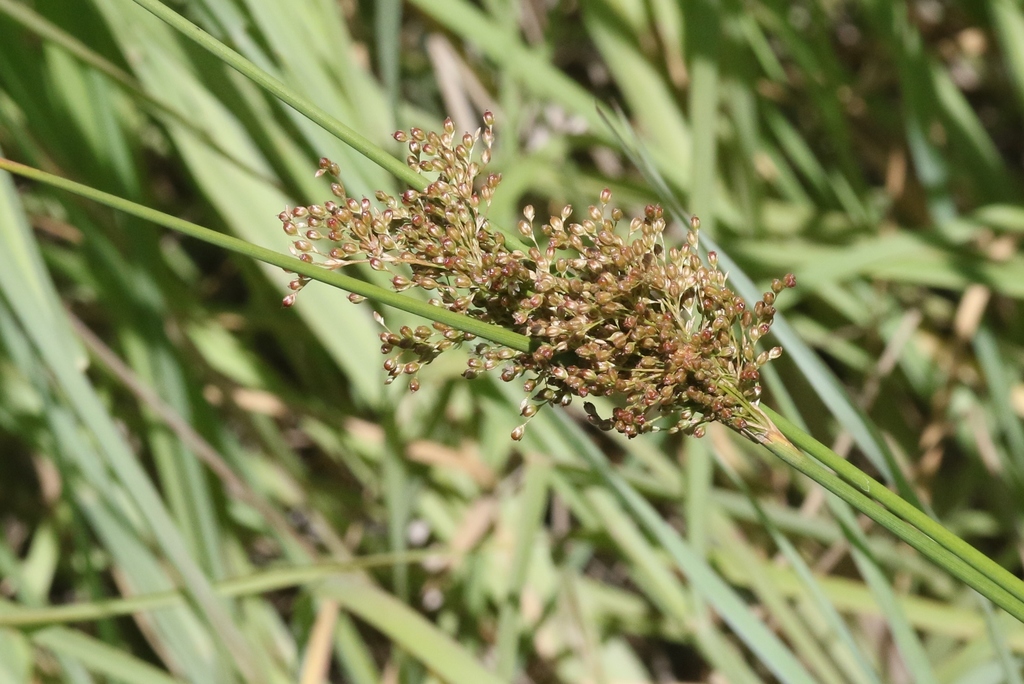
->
[0, 158, 531, 351]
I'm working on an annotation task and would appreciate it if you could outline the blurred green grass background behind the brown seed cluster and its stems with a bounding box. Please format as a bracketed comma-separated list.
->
[0, 0, 1024, 684]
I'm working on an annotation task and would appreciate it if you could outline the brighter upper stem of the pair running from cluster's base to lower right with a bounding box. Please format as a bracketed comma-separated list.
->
[762, 407, 1024, 622]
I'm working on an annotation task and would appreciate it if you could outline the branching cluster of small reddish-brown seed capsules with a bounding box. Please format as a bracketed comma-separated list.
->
[280, 113, 796, 439]
